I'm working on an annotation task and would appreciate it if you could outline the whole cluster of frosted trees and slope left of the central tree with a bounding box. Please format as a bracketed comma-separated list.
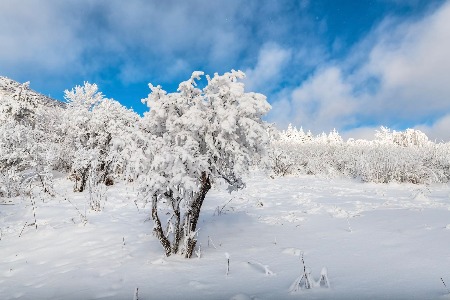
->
[0, 77, 139, 196]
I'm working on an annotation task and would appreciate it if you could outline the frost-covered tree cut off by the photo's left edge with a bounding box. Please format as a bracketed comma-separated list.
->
[0, 89, 58, 197]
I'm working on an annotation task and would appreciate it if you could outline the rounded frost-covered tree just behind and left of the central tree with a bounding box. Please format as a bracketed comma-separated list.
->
[59, 82, 138, 191]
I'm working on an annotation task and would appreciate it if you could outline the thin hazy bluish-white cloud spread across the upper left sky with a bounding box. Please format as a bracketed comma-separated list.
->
[0, 0, 250, 82]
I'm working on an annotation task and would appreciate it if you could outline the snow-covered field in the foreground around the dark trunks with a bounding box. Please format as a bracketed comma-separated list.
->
[0, 173, 450, 300]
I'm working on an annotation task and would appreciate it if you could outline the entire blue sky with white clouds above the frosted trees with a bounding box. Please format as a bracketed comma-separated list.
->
[0, 0, 450, 141]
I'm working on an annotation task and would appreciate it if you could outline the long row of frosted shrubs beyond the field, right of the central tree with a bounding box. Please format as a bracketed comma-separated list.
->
[270, 126, 450, 183]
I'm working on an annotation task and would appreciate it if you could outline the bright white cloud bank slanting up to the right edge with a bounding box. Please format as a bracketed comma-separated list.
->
[271, 2, 450, 138]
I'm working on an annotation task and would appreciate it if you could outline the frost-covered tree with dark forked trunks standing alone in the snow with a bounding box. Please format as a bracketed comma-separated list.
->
[136, 70, 270, 258]
